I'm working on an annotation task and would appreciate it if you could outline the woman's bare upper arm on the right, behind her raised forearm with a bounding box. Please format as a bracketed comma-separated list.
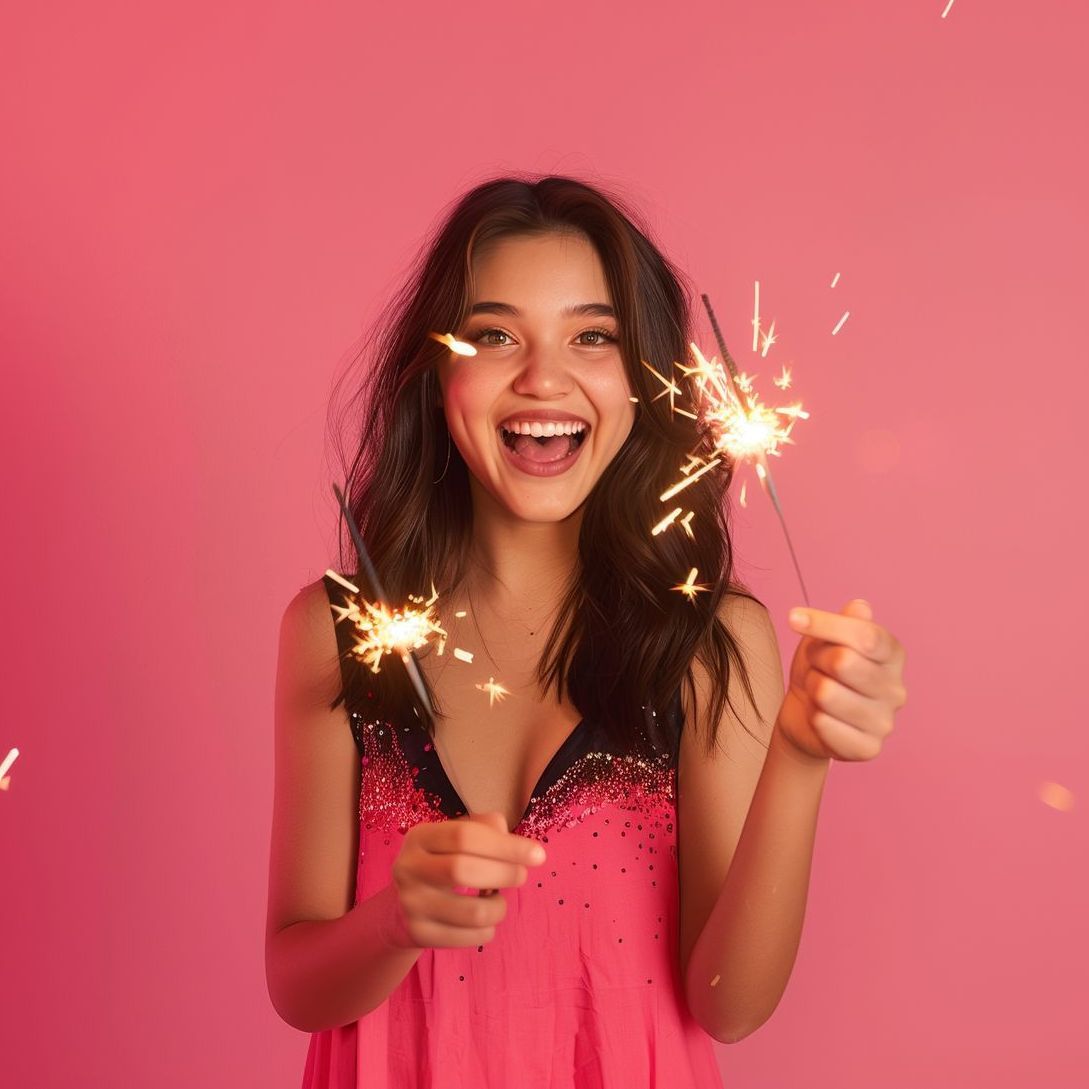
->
[677, 594, 785, 978]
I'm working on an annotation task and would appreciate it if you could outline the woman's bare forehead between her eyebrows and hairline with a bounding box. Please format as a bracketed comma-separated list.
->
[469, 232, 612, 309]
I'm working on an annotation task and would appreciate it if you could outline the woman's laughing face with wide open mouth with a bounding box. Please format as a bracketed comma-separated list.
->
[439, 233, 635, 522]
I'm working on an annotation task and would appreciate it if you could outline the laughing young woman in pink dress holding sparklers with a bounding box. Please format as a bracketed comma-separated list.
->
[266, 176, 906, 1089]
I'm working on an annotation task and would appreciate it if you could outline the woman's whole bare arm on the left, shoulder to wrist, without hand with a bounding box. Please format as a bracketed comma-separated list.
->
[265, 580, 420, 1032]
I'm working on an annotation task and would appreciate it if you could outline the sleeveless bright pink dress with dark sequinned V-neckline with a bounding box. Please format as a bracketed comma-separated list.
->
[303, 576, 722, 1089]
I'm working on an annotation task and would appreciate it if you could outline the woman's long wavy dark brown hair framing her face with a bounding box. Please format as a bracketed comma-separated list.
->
[333, 175, 759, 751]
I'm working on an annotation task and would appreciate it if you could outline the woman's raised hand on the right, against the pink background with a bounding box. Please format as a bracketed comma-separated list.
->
[775, 599, 907, 760]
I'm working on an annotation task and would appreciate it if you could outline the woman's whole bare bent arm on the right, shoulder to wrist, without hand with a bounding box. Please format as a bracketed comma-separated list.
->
[678, 598, 830, 1043]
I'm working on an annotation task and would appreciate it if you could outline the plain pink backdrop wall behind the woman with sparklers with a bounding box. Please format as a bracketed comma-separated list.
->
[0, 0, 1089, 1089]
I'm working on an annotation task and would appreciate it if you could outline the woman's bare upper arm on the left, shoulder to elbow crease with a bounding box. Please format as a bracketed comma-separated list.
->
[266, 579, 360, 949]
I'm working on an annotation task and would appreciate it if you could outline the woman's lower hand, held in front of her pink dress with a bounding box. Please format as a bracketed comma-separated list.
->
[392, 812, 546, 949]
